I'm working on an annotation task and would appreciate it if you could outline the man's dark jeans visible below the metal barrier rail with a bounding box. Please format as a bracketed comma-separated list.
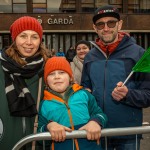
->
[101, 138, 140, 150]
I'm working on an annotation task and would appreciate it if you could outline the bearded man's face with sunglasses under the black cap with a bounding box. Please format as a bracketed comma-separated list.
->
[93, 17, 123, 44]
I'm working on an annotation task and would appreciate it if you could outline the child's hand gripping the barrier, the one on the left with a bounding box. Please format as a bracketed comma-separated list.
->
[47, 122, 72, 142]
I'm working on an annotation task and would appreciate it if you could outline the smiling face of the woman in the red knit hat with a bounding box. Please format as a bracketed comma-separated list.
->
[16, 30, 41, 58]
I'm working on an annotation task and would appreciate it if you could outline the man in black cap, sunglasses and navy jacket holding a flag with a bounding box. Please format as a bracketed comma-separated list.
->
[81, 5, 150, 150]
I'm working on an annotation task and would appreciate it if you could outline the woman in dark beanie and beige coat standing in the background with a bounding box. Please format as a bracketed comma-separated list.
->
[70, 40, 91, 84]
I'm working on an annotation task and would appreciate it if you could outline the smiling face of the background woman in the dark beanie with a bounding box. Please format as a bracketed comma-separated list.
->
[76, 44, 90, 60]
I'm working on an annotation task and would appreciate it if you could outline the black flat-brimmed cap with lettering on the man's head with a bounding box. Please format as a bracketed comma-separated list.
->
[93, 5, 120, 24]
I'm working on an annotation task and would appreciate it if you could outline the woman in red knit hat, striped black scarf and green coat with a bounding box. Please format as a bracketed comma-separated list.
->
[0, 16, 49, 150]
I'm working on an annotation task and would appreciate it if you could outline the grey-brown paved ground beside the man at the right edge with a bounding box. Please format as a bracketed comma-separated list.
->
[140, 107, 150, 150]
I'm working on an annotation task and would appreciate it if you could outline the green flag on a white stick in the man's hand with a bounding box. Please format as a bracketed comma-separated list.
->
[122, 47, 150, 86]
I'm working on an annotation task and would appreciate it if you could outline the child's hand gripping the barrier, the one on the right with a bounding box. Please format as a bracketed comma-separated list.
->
[79, 121, 101, 144]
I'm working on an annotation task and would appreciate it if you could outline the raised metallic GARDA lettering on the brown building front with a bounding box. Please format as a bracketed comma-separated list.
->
[47, 17, 73, 25]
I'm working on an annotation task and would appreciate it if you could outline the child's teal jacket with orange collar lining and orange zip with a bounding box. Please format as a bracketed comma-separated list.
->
[38, 84, 107, 150]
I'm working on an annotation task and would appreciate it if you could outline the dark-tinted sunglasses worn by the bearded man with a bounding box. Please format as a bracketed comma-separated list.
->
[95, 20, 118, 30]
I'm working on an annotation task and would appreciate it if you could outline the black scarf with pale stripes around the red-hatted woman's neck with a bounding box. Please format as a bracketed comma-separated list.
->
[0, 50, 43, 117]
